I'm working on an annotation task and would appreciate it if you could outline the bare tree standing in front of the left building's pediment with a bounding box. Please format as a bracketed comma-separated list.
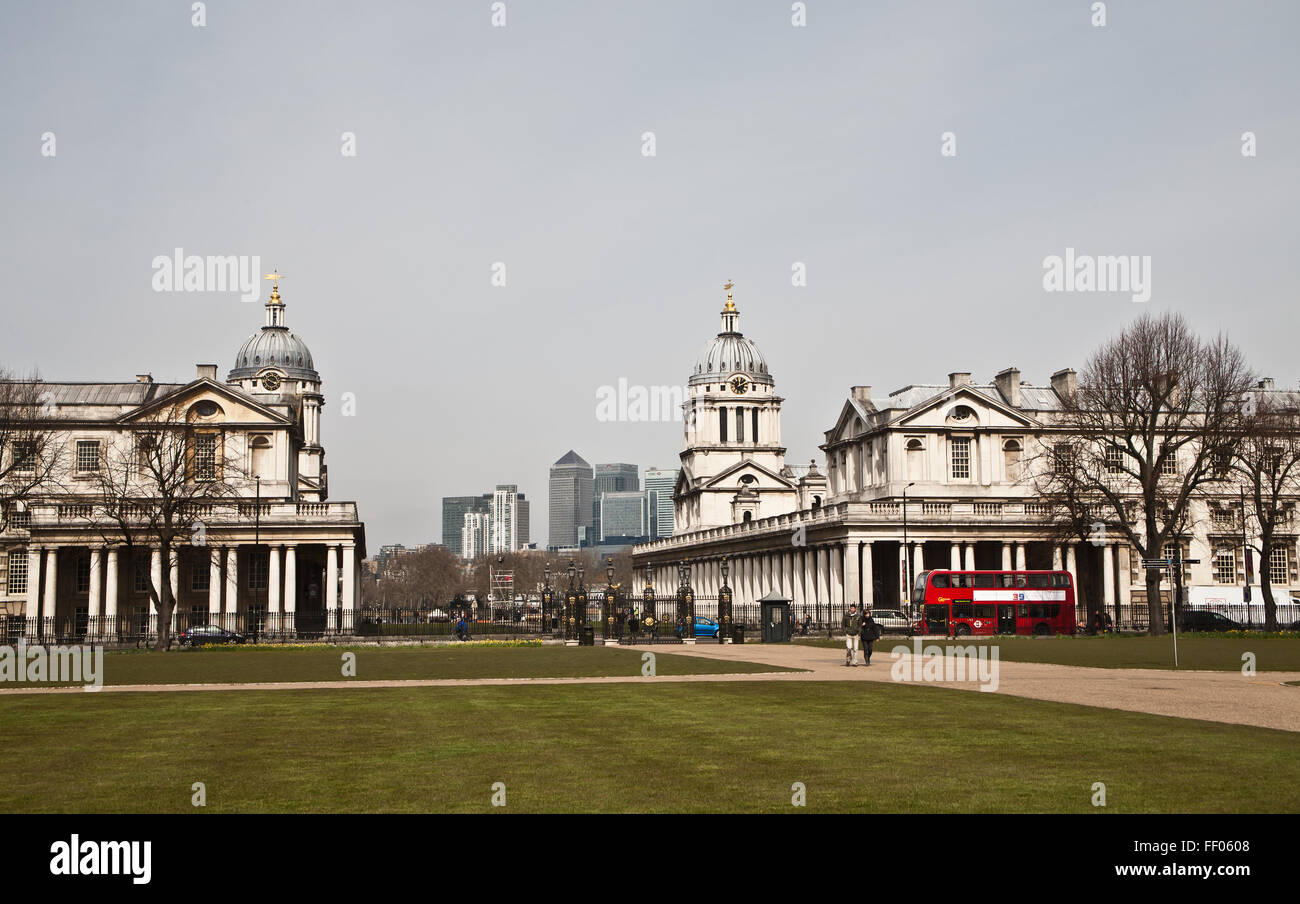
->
[85, 403, 247, 650]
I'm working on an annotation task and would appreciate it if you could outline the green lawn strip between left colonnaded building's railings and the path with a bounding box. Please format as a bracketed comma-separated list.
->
[9, 644, 789, 687]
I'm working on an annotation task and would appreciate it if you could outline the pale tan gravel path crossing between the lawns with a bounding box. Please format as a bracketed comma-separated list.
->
[0, 641, 1300, 731]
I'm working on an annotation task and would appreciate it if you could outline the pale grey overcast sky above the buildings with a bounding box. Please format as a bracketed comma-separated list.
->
[0, 0, 1300, 552]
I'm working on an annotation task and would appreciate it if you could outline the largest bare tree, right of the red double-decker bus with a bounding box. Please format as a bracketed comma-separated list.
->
[1036, 313, 1253, 635]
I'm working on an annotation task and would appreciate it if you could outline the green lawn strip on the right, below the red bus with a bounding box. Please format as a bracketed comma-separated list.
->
[797, 635, 1300, 671]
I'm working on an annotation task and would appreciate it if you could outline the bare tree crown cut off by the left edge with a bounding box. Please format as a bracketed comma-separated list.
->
[0, 367, 62, 532]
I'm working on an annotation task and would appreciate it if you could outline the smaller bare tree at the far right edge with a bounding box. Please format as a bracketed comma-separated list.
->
[1217, 394, 1300, 631]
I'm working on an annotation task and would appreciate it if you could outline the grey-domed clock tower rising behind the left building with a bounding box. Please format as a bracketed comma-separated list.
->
[226, 272, 329, 502]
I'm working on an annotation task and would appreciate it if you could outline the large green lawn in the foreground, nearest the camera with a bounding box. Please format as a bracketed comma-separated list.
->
[0, 682, 1300, 813]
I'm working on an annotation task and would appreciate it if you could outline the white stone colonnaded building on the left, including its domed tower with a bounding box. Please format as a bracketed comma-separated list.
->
[0, 279, 365, 639]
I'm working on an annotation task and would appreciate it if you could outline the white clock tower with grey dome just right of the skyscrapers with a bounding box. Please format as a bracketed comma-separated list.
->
[675, 282, 797, 533]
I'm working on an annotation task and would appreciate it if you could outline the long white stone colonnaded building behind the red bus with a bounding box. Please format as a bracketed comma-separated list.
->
[633, 308, 1300, 620]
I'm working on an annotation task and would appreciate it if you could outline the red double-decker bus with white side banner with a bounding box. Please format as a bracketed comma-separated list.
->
[913, 571, 1076, 637]
